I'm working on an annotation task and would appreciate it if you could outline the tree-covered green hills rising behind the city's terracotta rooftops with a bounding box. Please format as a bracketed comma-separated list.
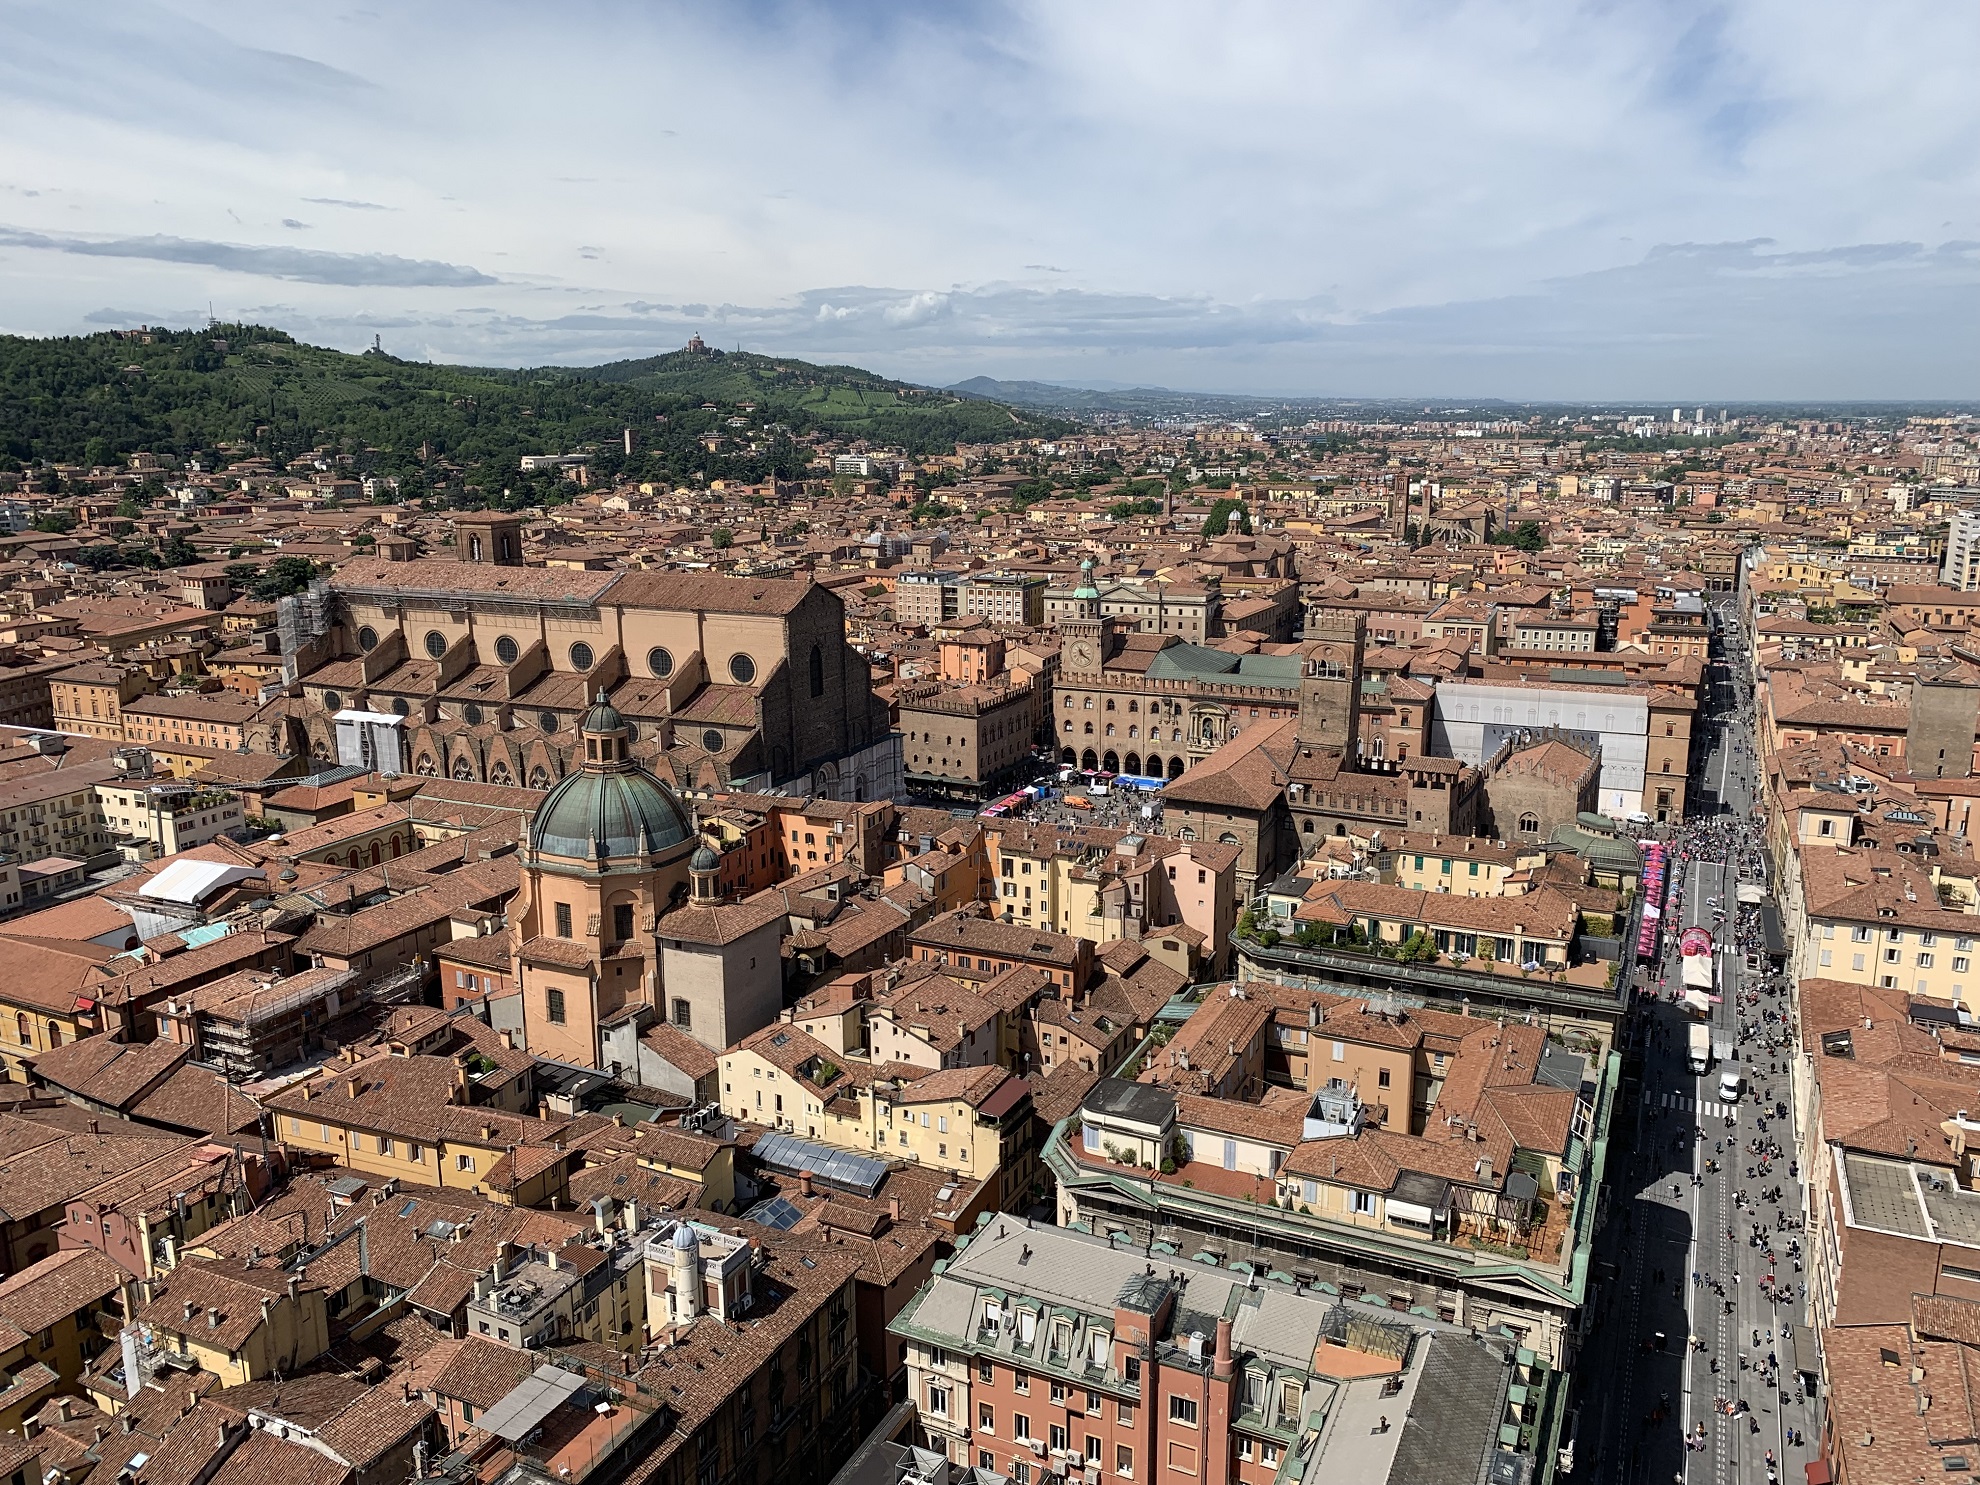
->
[0, 325, 1065, 505]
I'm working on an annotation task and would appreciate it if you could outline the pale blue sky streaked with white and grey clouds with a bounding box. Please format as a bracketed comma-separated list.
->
[0, 0, 1980, 402]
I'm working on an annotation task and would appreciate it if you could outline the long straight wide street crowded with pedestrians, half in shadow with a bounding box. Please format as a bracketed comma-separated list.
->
[1574, 606, 1820, 1485]
